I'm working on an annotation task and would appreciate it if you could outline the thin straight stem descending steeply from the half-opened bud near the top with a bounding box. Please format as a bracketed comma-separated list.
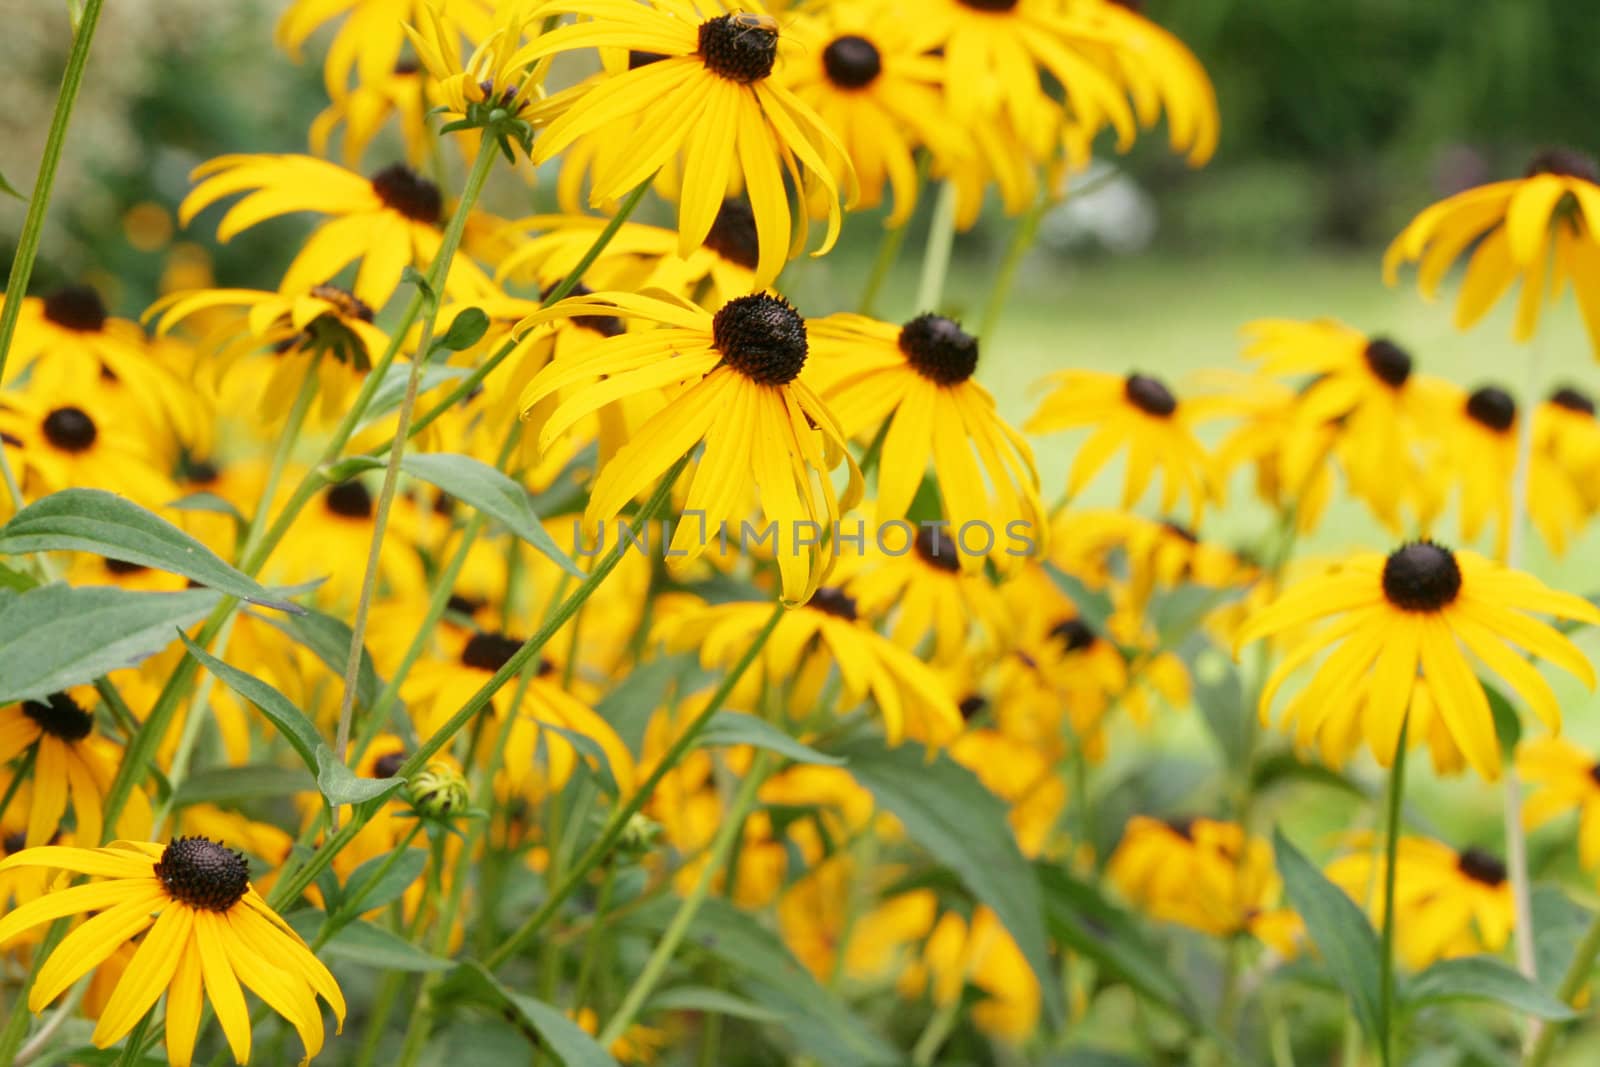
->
[328, 137, 494, 812]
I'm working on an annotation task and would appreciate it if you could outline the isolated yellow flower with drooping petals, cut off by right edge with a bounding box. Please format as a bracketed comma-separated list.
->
[1384, 149, 1600, 354]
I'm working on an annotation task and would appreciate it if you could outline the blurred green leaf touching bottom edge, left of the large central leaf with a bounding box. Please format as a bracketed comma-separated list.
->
[627, 897, 906, 1067]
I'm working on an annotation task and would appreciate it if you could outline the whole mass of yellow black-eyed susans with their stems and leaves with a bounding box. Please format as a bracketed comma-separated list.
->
[0, 0, 1600, 1064]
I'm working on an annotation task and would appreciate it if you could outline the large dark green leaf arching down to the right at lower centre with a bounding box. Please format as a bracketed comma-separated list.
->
[835, 737, 1064, 1022]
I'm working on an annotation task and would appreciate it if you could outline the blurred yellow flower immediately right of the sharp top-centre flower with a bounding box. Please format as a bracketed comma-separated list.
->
[779, 0, 971, 226]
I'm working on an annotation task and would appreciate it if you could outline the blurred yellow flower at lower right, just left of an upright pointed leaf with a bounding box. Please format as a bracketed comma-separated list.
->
[1107, 816, 1299, 955]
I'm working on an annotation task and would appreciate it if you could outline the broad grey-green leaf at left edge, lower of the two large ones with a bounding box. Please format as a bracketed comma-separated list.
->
[0, 582, 219, 704]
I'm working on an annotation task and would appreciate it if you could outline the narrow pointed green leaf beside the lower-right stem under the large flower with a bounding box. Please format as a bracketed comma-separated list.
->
[1272, 830, 1382, 1037]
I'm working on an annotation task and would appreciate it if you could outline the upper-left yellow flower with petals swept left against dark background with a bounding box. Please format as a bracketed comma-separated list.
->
[178, 155, 494, 309]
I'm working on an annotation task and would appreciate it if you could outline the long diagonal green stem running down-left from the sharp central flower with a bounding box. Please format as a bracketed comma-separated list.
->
[267, 456, 688, 907]
